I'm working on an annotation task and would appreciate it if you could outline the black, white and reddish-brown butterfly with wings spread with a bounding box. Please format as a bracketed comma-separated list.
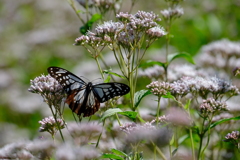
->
[48, 67, 130, 117]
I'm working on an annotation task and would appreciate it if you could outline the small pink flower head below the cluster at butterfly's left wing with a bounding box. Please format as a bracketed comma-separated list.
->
[39, 116, 65, 136]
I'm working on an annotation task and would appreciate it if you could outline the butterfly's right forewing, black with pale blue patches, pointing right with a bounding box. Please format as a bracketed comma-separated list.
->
[92, 82, 130, 103]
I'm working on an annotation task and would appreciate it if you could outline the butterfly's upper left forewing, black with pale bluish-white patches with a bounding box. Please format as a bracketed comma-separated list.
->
[48, 67, 87, 94]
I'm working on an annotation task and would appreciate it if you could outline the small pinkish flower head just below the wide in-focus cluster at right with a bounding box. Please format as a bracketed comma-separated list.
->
[200, 98, 228, 117]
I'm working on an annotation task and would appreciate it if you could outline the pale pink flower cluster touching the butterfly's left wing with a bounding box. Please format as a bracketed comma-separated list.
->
[28, 75, 65, 106]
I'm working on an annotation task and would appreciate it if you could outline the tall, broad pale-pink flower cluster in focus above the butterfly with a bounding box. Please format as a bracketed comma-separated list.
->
[75, 11, 166, 47]
